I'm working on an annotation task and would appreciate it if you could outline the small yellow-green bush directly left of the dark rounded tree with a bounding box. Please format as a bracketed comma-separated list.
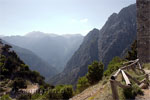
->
[77, 76, 89, 92]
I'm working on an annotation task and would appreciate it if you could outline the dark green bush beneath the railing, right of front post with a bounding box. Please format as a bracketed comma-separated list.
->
[123, 84, 143, 99]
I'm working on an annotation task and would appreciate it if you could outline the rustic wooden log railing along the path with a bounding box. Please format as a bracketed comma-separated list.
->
[110, 59, 148, 100]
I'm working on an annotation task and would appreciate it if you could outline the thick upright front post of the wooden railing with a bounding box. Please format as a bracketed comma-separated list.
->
[110, 80, 119, 100]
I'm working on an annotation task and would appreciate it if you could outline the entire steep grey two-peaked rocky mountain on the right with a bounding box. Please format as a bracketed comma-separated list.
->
[49, 4, 136, 84]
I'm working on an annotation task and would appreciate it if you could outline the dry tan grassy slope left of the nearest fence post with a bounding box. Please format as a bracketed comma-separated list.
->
[70, 82, 112, 100]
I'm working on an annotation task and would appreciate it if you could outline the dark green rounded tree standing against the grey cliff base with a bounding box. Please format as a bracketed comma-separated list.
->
[86, 61, 104, 84]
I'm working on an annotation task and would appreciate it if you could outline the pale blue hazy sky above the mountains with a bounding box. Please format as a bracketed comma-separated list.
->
[0, 0, 136, 36]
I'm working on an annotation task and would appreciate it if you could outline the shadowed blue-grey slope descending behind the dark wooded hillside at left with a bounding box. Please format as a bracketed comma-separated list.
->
[2, 41, 58, 80]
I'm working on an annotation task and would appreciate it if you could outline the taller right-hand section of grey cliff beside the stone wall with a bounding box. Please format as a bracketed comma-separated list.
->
[98, 5, 136, 67]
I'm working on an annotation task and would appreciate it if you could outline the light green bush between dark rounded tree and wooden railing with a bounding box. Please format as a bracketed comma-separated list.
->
[104, 57, 124, 76]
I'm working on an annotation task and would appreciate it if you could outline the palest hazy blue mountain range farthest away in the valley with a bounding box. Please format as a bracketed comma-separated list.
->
[2, 31, 83, 72]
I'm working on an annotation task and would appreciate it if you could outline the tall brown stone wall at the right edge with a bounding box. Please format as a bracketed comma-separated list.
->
[137, 0, 150, 63]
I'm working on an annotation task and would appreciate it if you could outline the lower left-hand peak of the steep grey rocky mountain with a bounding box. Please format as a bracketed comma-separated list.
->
[50, 29, 99, 84]
